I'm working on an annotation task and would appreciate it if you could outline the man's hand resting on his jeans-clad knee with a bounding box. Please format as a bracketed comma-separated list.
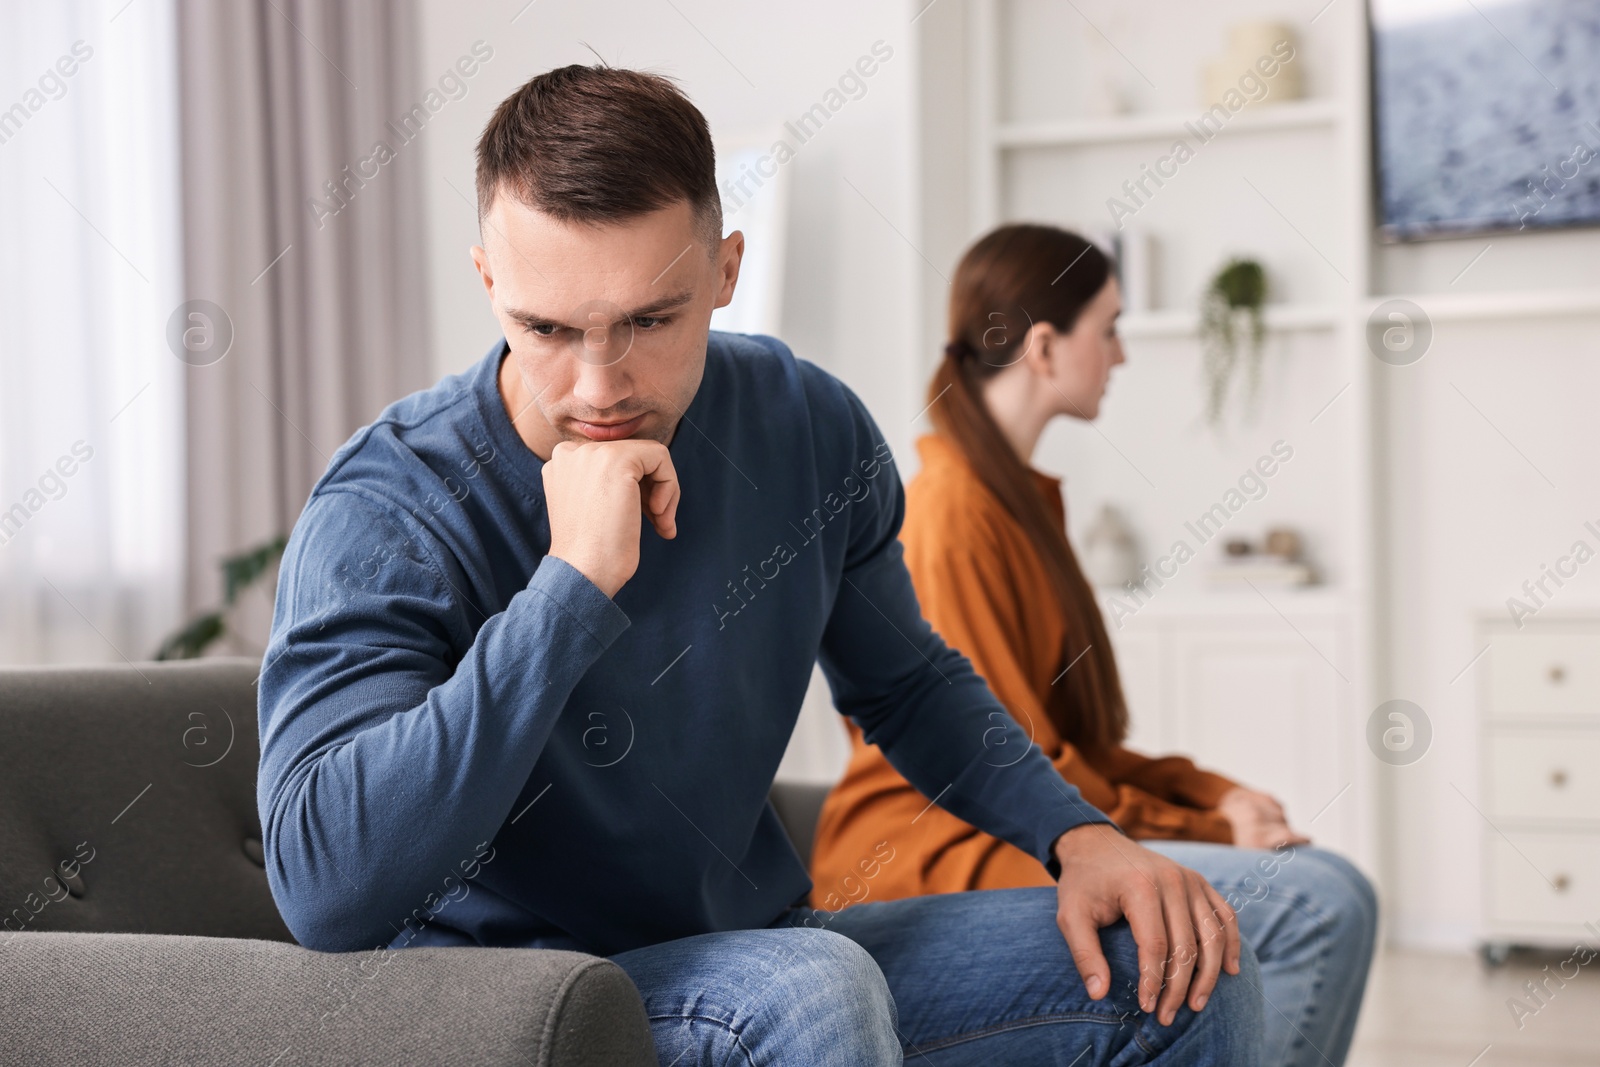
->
[1054, 822, 1238, 1025]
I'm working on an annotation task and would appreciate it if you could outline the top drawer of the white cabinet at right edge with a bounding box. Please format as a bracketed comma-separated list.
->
[1488, 630, 1600, 718]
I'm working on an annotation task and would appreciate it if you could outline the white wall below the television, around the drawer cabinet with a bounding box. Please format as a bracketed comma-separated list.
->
[1374, 230, 1600, 947]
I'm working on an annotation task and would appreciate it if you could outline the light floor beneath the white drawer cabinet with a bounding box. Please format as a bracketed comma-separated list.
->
[1347, 949, 1600, 1067]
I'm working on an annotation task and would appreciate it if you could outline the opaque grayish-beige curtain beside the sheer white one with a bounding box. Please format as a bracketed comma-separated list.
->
[178, 0, 430, 653]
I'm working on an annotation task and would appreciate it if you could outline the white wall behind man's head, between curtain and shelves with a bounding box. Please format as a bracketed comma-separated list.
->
[418, 0, 928, 781]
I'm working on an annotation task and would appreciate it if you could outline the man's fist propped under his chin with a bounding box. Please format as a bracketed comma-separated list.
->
[544, 440, 678, 597]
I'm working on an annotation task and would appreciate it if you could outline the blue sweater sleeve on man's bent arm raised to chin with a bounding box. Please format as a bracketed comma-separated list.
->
[256, 490, 629, 952]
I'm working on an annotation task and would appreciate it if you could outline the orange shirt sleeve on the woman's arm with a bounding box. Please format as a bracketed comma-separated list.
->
[914, 510, 1234, 843]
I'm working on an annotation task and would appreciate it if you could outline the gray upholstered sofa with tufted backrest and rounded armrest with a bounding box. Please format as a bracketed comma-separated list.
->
[0, 659, 826, 1067]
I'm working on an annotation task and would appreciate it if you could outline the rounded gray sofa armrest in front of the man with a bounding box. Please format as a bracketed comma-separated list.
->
[0, 931, 656, 1067]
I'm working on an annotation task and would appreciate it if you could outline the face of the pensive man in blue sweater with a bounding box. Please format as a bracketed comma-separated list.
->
[472, 194, 744, 459]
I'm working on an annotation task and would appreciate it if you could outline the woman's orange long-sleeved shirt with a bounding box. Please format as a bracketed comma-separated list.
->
[811, 434, 1235, 909]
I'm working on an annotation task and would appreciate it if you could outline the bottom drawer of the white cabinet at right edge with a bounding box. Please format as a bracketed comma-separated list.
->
[1488, 832, 1600, 926]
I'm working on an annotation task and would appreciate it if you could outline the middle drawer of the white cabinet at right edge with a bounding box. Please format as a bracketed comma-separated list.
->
[1485, 731, 1600, 821]
